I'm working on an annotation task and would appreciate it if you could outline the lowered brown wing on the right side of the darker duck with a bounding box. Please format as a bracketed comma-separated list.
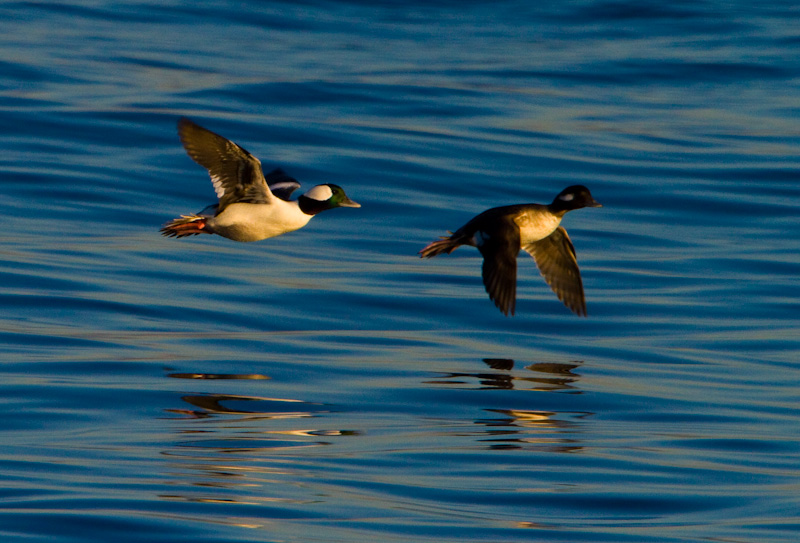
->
[523, 226, 586, 317]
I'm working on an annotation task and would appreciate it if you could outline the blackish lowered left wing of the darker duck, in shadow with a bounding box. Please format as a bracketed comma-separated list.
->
[477, 216, 520, 315]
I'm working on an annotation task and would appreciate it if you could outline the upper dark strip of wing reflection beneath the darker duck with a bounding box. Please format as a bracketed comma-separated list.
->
[426, 358, 582, 394]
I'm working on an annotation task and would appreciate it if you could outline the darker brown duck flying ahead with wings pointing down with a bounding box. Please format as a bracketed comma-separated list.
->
[419, 185, 602, 316]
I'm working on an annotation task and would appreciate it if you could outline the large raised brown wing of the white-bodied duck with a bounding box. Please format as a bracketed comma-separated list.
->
[178, 118, 272, 211]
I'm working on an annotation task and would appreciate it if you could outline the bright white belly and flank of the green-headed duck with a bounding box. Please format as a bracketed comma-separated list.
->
[208, 199, 311, 241]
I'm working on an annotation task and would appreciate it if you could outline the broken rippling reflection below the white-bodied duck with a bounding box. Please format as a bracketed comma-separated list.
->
[159, 373, 358, 510]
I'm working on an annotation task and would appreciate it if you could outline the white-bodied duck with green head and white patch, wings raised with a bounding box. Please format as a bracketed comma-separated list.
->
[161, 118, 361, 241]
